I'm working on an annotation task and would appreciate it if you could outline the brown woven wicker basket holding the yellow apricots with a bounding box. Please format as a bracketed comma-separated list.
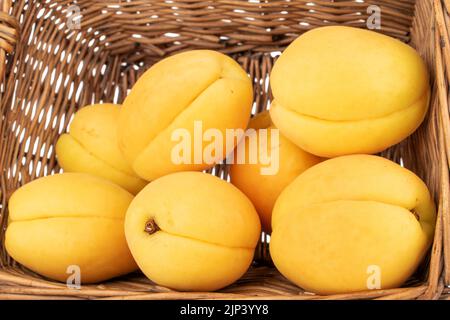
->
[0, 0, 450, 299]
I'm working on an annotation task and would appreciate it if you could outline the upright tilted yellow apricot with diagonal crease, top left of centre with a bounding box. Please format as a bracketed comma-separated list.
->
[119, 50, 253, 180]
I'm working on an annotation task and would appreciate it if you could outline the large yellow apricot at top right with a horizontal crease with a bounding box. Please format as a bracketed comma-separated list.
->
[270, 26, 430, 158]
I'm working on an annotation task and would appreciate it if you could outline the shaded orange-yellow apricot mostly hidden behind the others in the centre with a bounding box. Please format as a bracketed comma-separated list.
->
[230, 115, 322, 233]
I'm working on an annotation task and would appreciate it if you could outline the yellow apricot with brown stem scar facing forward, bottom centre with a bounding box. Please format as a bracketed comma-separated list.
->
[125, 172, 260, 291]
